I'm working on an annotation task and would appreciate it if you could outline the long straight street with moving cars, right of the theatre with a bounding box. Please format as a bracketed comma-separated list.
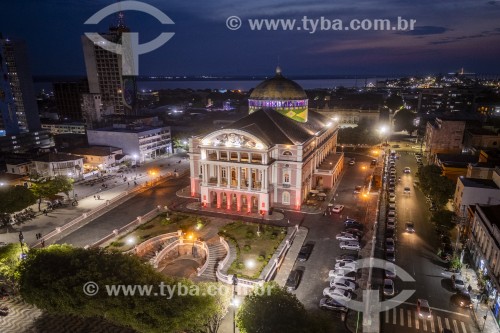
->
[377, 148, 476, 333]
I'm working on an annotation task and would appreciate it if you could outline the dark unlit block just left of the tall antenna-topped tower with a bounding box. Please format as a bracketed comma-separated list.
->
[54, 79, 89, 121]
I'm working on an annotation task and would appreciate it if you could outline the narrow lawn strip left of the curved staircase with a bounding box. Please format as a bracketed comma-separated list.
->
[107, 213, 210, 252]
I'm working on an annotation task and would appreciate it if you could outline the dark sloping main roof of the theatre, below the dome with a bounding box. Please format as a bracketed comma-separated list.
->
[226, 109, 331, 146]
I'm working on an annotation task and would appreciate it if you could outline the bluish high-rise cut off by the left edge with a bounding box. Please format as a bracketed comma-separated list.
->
[0, 36, 40, 136]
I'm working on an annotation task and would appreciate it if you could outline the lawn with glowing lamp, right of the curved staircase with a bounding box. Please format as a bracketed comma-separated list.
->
[219, 221, 286, 279]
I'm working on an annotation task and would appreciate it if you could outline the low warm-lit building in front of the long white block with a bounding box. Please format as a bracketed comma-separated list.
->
[70, 146, 123, 172]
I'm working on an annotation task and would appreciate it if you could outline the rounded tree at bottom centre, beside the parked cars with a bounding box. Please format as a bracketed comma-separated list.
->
[236, 282, 331, 333]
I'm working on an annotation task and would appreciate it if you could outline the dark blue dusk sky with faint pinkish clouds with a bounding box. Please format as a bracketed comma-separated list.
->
[0, 0, 500, 75]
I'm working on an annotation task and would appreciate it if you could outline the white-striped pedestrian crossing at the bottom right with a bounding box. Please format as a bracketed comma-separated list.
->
[382, 308, 475, 333]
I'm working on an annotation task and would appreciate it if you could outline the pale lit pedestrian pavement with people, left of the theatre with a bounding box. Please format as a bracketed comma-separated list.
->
[0, 155, 189, 244]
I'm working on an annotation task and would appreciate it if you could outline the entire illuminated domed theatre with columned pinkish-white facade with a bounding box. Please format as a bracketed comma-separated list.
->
[189, 70, 342, 214]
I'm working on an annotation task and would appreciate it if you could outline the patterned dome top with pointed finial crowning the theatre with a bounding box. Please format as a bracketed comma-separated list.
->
[248, 66, 307, 100]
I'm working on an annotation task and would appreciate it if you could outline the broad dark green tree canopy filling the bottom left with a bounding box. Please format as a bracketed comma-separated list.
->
[18, 245, 213, 333]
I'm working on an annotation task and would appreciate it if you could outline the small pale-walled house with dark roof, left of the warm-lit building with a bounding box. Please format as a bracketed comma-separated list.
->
[31, 153, 83, 179]
